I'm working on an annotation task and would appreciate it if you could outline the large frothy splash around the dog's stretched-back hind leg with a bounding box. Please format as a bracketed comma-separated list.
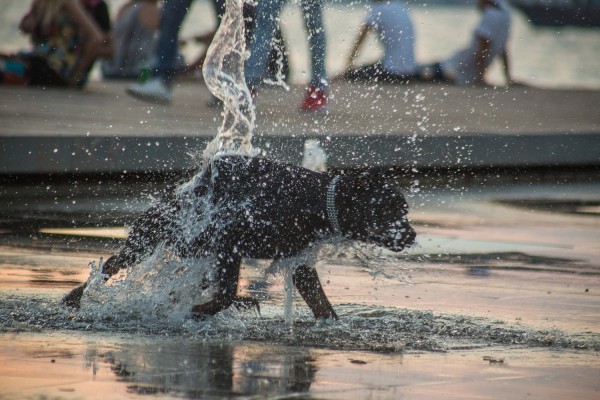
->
[79, 255, 215, 327]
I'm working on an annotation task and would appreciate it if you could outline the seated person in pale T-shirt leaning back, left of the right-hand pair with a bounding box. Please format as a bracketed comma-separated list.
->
[420, 0, 513, 85]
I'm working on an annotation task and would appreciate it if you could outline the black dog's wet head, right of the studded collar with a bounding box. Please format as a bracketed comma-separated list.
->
[346, 179, 416, 251]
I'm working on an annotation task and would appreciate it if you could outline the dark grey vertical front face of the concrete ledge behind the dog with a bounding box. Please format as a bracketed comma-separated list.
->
[0, 133, 600, 174]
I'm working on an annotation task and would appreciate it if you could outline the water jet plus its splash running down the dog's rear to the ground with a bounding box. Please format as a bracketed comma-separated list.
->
[81, 0, 255, 323]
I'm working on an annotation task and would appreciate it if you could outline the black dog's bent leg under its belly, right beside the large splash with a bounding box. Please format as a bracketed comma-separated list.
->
[192, 250, 242, 318]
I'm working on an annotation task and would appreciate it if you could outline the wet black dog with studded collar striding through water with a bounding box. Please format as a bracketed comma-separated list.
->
[63, 156, 416, 318]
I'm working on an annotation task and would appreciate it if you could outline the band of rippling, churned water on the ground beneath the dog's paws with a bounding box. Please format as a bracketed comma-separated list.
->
[0, 296, 600, 352]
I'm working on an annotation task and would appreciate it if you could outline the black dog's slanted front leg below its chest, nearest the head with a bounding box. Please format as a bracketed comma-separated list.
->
[292, 265, 338, 319]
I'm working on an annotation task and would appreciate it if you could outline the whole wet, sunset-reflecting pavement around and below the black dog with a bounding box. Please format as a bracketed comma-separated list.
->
[0, 175, 600, 399]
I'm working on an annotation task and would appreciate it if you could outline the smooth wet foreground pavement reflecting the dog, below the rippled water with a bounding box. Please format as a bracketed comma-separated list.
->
[0, 333, 600, 399]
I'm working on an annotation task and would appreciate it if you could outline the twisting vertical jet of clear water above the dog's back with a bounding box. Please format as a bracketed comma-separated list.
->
[202, 0, 255, 168]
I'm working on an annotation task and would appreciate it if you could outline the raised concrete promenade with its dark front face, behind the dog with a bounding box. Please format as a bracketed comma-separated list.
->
[0, 81, 600, 174]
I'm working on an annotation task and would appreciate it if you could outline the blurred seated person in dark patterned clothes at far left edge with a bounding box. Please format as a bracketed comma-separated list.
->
[0, 0, 111, 87]
